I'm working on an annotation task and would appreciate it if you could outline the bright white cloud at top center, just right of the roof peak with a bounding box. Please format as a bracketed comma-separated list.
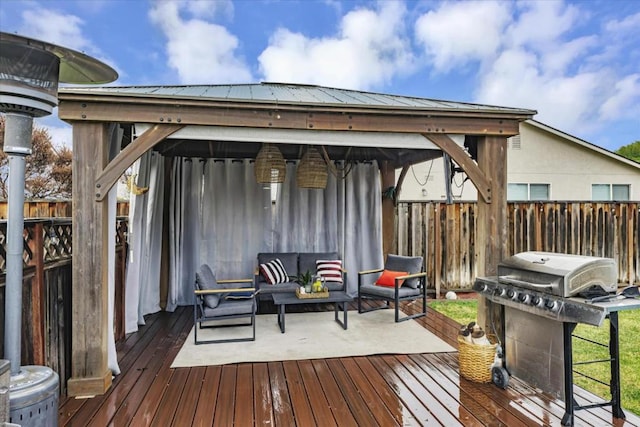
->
[258, 2, 413, 89]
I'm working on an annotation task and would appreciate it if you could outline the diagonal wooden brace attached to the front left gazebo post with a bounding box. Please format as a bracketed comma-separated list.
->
[95, 124, 184, 200]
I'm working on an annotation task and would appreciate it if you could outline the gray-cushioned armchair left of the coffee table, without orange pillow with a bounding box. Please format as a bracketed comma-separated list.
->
[193, 264, 257, 344]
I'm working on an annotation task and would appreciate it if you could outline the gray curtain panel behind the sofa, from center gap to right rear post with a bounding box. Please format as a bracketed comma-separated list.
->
[274, 162, 383, 295]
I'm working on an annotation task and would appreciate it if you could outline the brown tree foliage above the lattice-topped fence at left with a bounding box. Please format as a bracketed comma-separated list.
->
[0, 116, 72, 200]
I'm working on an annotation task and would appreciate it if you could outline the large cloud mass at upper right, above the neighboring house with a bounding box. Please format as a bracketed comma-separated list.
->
[416, 1, 640, 139]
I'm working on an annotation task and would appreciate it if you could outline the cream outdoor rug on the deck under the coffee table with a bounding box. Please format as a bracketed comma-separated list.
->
[171, 310, 455, 368]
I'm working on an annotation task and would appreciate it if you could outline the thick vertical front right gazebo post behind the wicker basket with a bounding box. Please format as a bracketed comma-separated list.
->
[476, 137, 508, 333]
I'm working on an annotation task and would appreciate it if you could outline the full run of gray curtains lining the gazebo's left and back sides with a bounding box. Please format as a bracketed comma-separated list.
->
[126, 152, 383, 332]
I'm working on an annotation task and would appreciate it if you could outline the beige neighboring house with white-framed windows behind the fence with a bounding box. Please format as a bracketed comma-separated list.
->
[398, 120, 640, 201]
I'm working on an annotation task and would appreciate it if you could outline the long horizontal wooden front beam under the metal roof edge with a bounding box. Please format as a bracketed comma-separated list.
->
[58, 99, 530, 136]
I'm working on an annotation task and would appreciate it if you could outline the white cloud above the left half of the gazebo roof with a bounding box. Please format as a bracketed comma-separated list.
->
[149, 1, 252, 84]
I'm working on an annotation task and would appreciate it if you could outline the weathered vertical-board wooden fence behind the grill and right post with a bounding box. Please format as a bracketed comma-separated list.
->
[395, 202, 640, 295]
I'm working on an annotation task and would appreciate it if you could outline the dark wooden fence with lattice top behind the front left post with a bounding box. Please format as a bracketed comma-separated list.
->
[0, 217, 127, 394]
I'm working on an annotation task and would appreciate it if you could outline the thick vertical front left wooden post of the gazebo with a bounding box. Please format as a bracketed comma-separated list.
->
[67, 123, 113, 396]
